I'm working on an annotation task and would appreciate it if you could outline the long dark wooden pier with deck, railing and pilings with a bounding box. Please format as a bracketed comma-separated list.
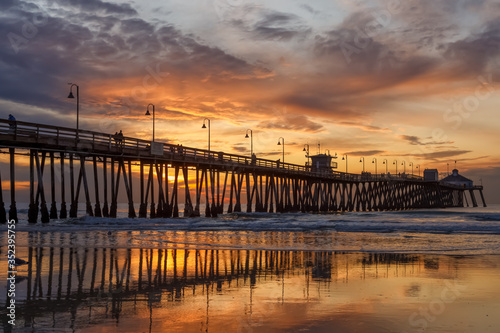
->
[0, 120, 485, 223]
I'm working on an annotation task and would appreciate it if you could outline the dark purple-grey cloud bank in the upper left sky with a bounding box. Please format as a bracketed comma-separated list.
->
[0, 0, 266, 121]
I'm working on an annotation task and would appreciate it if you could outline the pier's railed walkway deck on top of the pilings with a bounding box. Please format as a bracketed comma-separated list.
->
[0, 119, 422, 181]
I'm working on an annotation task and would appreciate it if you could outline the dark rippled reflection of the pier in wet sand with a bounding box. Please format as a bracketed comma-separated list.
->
[4, 238, 456, 329]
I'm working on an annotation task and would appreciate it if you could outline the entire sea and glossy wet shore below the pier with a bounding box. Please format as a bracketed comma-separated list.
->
[0, 205, 500, 333]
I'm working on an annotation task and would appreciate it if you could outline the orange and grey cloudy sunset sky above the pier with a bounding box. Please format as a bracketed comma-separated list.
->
[0, 0, 500, 202]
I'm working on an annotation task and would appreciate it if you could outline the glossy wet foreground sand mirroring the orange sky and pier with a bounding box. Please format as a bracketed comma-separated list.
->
[0, 231, 500, 332]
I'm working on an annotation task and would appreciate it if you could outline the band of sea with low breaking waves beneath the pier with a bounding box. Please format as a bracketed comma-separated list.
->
[6, 205, 500, 255]
